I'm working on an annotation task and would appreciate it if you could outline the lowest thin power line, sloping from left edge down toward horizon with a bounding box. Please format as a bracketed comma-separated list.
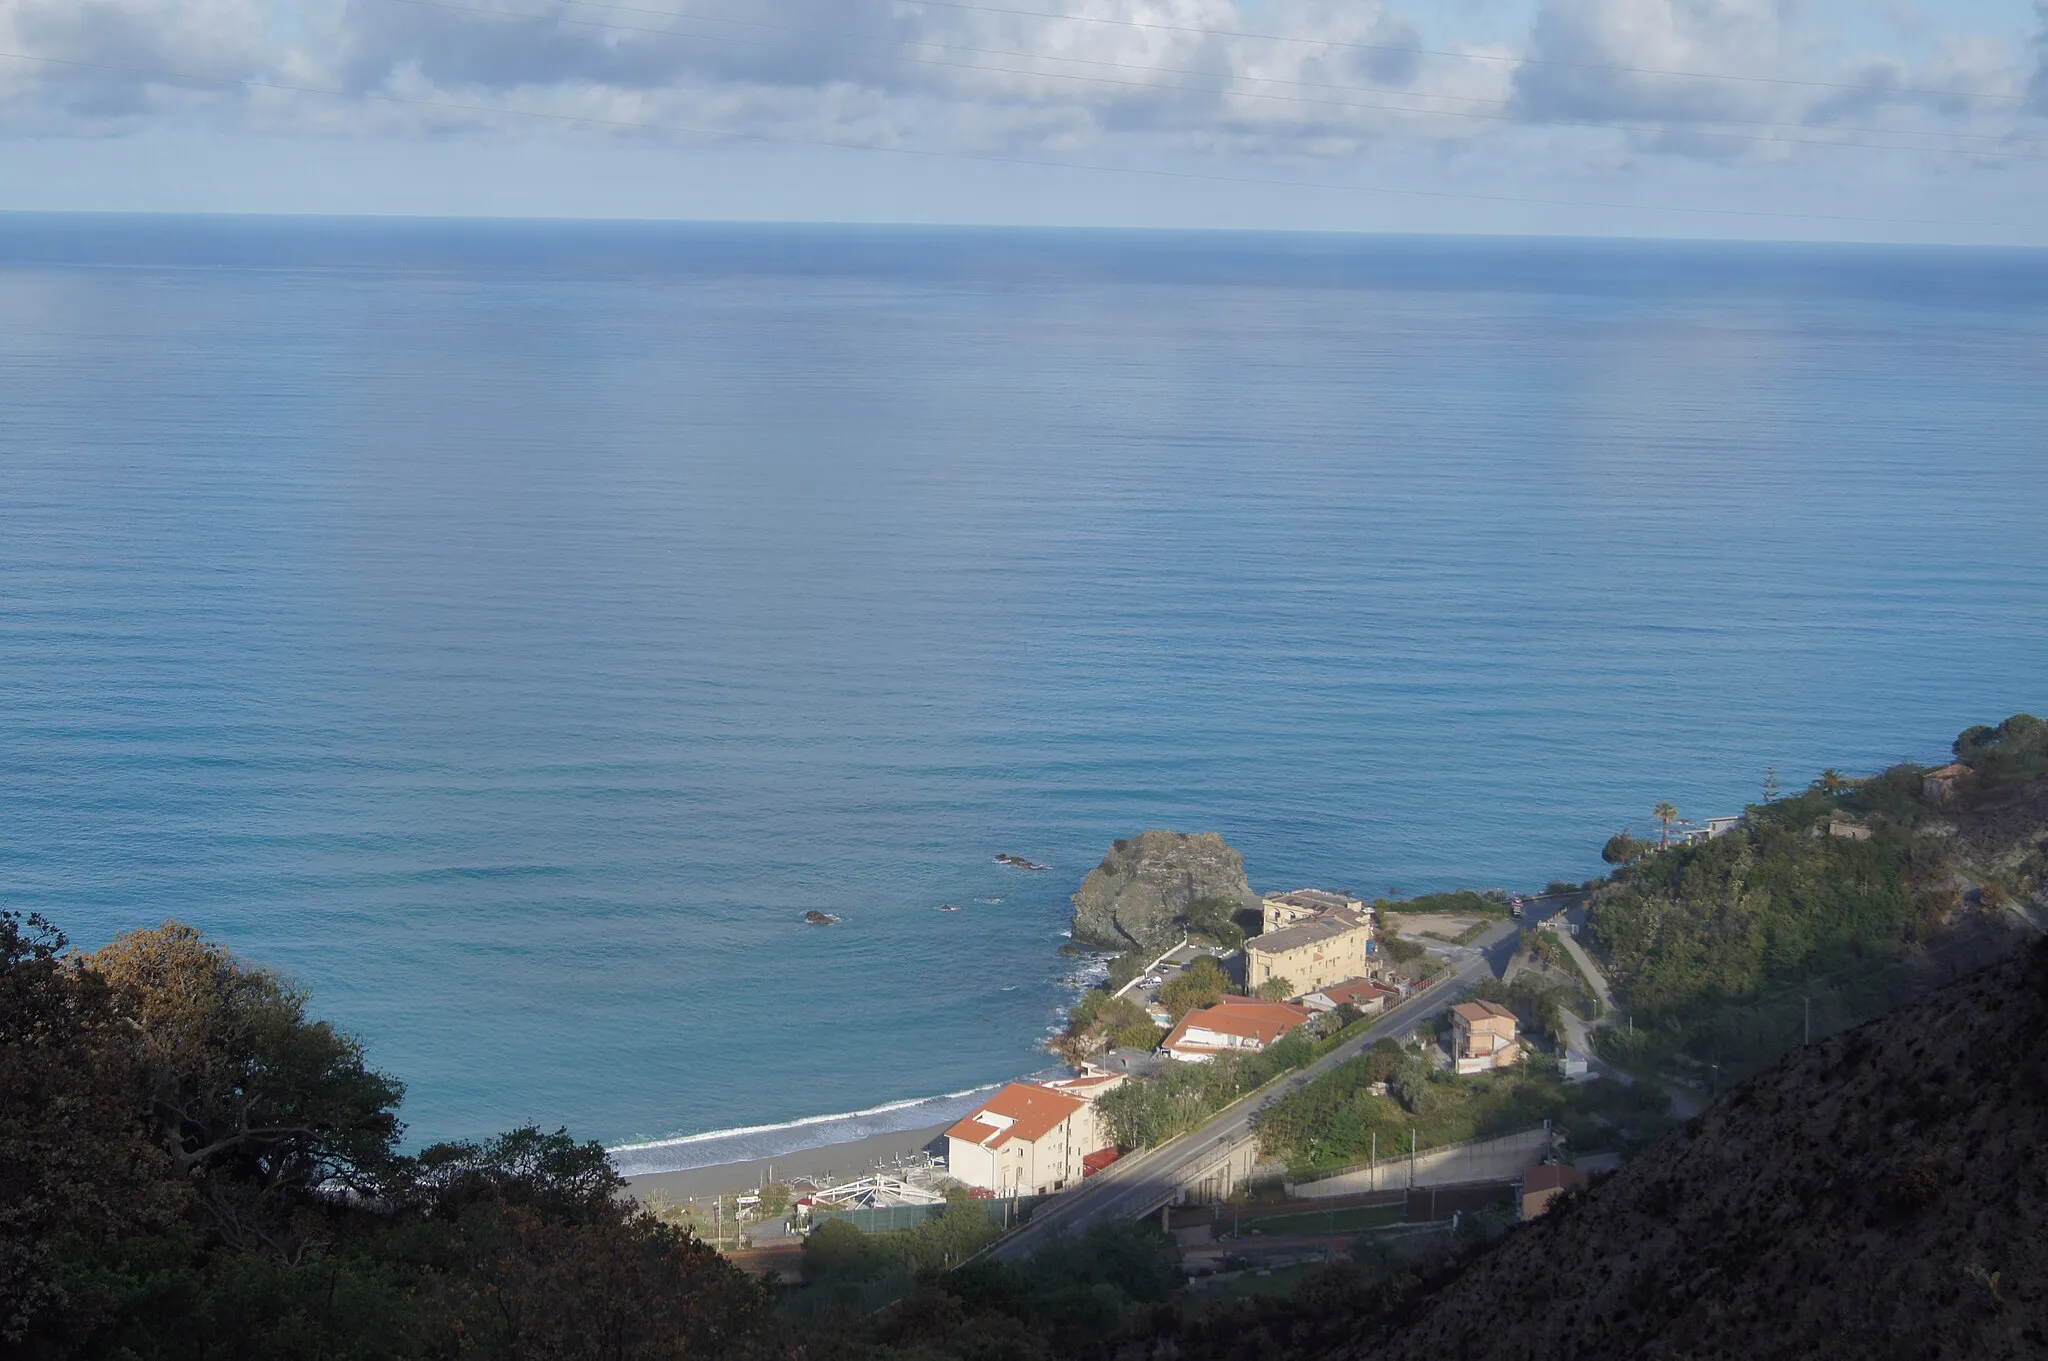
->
[0, 51, 2011, 229]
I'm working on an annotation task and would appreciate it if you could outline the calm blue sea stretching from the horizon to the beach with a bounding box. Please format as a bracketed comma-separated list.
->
[0, 215, 2048, 1169]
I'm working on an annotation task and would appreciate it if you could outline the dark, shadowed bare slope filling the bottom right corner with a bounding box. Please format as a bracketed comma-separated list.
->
[1325, 946, 2048, 1361]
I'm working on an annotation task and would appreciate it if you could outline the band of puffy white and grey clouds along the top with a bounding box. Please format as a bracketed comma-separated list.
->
[0, 0, 2048, 164]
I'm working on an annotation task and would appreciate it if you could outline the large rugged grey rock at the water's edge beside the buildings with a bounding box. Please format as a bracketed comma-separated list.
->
[1073, 831, 1260, 950]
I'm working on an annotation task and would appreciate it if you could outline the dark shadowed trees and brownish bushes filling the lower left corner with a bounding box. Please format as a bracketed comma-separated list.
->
[0, 913, 772, 1361]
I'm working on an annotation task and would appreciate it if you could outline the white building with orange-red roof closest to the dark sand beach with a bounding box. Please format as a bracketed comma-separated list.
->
[946, 1072, 1124, 1195]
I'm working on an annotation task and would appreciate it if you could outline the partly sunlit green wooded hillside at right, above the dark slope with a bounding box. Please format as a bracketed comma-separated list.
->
[1587, 714, 2048, 1077]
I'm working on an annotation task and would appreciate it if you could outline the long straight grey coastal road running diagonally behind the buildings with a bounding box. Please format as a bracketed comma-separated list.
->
[987, 919, 1522, 1261]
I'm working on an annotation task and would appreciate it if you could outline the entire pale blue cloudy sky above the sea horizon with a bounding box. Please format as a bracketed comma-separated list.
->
[0, 0, 2048, 246]
